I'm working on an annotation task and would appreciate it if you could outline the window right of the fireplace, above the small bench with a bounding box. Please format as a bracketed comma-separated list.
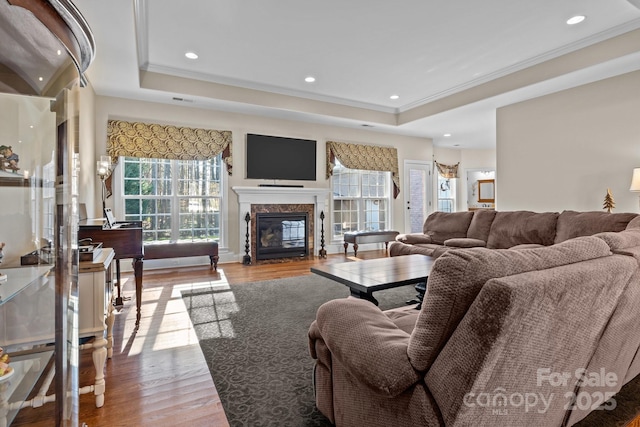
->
[332, 161, 391, 239]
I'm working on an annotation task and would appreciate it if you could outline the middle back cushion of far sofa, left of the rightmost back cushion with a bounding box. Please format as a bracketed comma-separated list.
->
[487, 211, 558, 249]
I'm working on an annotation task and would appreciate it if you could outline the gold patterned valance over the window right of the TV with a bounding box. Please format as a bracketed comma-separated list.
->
[327, 141, 400, 199]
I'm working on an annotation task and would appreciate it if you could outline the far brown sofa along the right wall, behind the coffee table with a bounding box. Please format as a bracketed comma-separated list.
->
[389, 210, 640, 257]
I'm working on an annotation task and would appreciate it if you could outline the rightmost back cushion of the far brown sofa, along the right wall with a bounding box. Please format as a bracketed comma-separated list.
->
[554, 211, 638, 243]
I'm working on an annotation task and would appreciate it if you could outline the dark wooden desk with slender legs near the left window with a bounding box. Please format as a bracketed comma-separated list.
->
[78, 219, 144, 325]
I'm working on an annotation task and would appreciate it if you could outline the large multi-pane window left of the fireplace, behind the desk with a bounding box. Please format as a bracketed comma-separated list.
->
[122, 155, 223, 243]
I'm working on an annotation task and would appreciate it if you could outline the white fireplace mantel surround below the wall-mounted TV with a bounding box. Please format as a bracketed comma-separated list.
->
[231, 186, 331, 261]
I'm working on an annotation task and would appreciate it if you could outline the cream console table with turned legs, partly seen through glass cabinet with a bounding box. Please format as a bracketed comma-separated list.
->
[0, 258, 115, 426]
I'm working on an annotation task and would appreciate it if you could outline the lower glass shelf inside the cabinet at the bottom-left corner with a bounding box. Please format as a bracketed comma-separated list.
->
[0, 350, 53, 425]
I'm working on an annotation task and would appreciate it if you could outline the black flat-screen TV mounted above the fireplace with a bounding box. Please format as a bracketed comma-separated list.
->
[246, 133, 316, 181]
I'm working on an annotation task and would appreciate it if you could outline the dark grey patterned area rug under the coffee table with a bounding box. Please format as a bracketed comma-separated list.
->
[182, 274, 416, 427]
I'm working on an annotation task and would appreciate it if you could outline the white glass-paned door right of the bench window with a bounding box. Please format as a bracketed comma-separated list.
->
[403, 160, 431, 233]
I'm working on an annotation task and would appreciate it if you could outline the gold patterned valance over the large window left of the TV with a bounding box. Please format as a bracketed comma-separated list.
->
[107, 120, 233, 175]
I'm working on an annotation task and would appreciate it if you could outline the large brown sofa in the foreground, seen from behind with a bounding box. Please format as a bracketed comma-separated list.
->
[309, 212, 640, 427]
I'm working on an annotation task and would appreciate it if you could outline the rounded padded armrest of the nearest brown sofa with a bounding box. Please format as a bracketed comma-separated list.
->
[316, 298, 421, 397]
